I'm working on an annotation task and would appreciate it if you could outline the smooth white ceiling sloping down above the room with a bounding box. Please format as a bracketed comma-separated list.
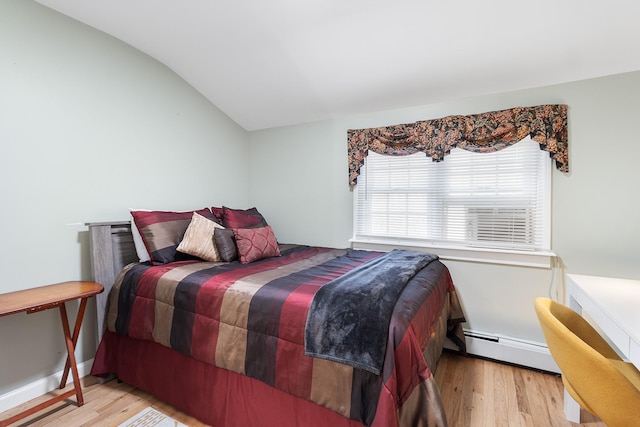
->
[37, 0, 640, 130]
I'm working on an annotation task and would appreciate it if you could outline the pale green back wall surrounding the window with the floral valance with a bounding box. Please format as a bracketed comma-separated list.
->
[250, 72, 640, 342]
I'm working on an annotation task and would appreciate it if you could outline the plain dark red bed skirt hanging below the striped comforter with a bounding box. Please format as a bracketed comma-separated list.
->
[91, 331, 456, 427]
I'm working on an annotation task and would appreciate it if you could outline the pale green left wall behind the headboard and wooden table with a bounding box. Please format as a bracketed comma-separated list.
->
[0, 0, 249, 396]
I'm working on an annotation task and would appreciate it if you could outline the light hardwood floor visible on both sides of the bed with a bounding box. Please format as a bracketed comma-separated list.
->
[0, 352, 606, 427]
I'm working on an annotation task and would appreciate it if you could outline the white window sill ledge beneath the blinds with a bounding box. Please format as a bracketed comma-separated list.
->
[349, 239, 556, 269]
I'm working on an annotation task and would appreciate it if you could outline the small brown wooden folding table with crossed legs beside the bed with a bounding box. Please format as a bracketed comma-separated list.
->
[0, 282, 104, 427]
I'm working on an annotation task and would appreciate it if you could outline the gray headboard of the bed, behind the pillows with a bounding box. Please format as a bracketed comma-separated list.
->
[85, 221, 138, 342]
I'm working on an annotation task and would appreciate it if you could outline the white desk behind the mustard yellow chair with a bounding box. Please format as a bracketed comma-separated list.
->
[564, 274, 640, 423]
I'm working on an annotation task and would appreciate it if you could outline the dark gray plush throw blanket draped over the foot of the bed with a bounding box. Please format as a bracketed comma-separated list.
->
[305, 249, 438, 375]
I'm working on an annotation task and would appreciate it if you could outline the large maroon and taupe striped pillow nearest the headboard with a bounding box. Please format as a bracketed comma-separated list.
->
[131, 208, 213, 265]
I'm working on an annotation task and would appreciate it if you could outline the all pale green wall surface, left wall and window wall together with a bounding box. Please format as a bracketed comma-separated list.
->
[0, 0, 640, 412]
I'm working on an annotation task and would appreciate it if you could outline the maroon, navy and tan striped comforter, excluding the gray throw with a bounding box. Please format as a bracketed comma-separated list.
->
[107, 246, 464, 426]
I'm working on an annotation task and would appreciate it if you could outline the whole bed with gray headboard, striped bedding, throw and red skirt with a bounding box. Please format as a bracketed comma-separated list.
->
[88, 210, 464, 427]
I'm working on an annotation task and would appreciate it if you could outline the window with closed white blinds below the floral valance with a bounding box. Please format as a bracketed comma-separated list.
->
[353, 138, 551, 251]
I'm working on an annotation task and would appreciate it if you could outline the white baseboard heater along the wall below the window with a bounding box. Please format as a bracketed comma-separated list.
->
[453, 330, 560, 373]
